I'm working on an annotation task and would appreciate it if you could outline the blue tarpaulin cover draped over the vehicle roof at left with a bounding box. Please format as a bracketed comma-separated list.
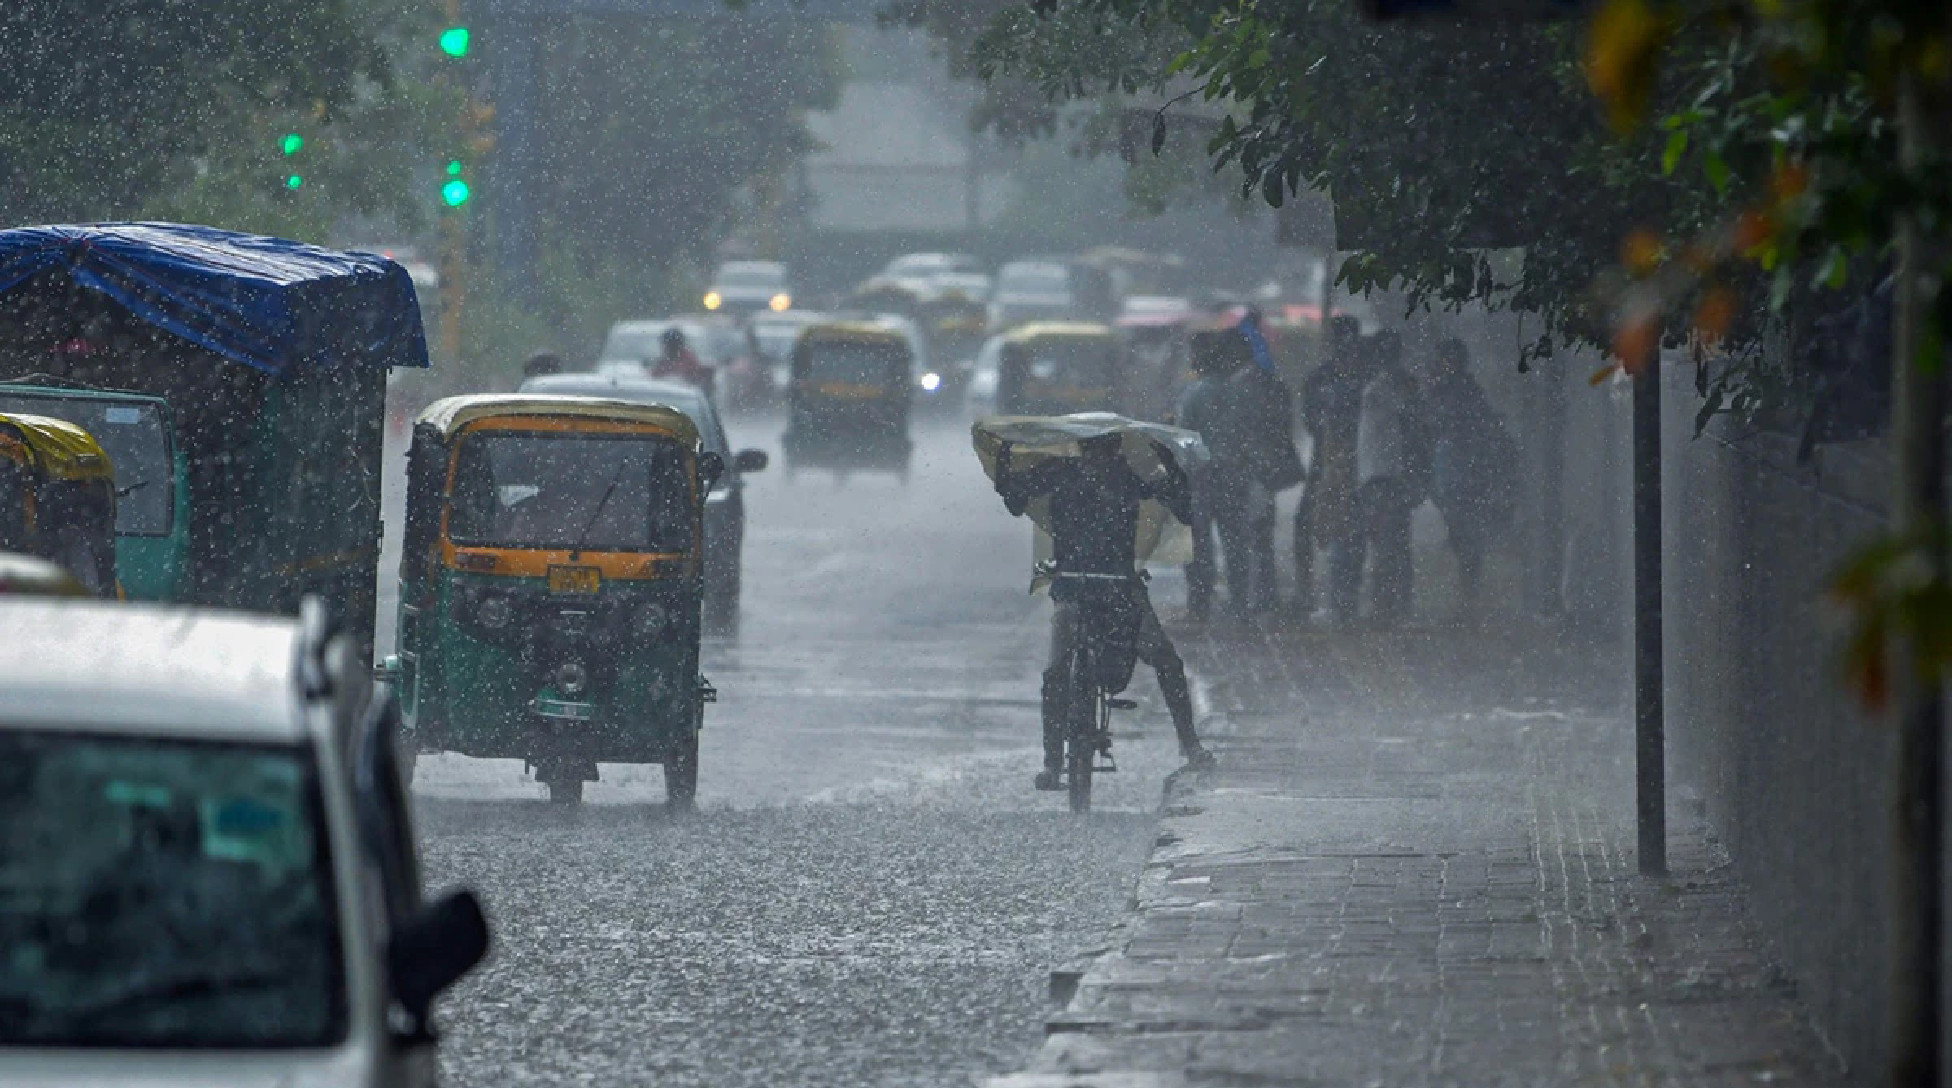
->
[0, 223, 427, 375]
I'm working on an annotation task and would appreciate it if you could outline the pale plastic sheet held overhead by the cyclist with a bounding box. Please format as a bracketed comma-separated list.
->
[970, 412, 1208, 592]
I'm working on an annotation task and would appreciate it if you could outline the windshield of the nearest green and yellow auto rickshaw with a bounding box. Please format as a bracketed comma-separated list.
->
[447, 434, 691, 553]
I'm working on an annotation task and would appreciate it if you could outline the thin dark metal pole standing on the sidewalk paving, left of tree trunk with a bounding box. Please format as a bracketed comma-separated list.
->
[1634, 354, 1667, 877]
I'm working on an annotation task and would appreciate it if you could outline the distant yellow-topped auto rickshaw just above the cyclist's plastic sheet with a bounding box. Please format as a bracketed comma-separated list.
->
[996, 320, 1126, 416]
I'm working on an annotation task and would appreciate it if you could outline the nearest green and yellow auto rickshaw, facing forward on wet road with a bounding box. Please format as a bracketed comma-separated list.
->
[386, 395, 724, 809]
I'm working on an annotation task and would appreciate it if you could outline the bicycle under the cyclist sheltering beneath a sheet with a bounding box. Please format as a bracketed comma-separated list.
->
[1052, 570, 1142, 813]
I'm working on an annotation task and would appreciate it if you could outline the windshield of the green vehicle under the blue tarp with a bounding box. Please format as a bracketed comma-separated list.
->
[0, 389, 176, 537]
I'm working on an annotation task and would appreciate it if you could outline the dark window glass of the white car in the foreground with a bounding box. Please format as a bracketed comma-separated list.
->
[0, 732, 346, 1049]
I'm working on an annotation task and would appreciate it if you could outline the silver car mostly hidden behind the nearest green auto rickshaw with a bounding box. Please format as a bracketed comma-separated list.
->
[521, 373, 767, 635]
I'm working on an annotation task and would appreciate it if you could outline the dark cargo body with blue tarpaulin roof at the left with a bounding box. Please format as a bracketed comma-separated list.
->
[0, 223, 427, 647]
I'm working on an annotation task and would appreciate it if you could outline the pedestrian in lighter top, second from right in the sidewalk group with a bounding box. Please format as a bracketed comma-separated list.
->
[1355, 330, 1431, 627]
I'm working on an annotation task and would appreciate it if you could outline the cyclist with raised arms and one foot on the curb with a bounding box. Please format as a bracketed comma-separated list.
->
[996, 434, 1212, 789]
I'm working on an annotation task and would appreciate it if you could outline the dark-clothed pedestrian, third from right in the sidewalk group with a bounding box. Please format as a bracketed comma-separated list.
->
[1294, 314, 1362, 619]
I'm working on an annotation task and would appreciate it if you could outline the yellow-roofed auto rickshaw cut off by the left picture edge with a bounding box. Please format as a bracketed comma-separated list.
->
[0, 412, 117, 598]
